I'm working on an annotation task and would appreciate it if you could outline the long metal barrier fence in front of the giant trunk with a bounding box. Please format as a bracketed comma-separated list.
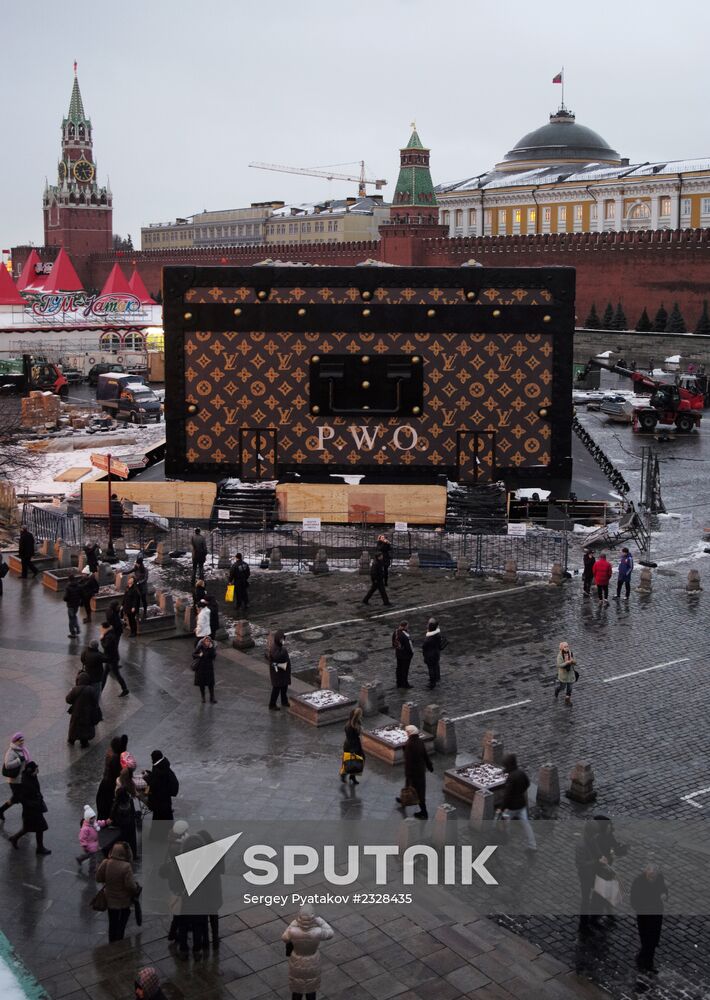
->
[29, 504, 568, 573]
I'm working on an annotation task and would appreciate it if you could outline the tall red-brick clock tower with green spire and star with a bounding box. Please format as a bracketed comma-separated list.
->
[42, 63, 113, 282]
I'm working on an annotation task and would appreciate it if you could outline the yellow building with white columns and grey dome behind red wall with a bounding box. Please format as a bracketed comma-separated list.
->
[436, 104, 710, 236]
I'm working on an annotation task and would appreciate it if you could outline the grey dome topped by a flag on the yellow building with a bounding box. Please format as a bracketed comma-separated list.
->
[496, 107, 621, 173]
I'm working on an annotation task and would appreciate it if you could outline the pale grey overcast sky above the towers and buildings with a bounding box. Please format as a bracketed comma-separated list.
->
[5, 0, 710, 247]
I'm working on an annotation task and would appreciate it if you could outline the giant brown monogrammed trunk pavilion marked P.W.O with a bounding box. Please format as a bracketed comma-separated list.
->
[163, 266, 574, 485]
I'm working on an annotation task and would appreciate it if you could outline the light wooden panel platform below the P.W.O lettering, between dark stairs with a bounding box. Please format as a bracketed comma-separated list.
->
[276, 481, 446, 525]
